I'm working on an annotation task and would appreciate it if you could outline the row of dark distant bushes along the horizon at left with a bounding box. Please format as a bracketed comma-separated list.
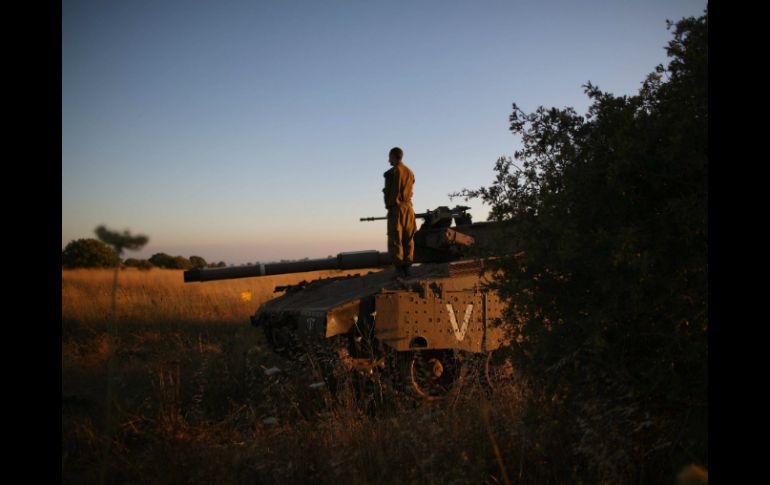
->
[62, 238, 227, 270]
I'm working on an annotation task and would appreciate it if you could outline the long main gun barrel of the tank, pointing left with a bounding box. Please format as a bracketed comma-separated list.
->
[184, 250, 391, 283]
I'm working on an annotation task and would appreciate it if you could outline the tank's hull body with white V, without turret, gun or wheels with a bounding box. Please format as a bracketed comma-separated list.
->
[252, 261, 505, 353]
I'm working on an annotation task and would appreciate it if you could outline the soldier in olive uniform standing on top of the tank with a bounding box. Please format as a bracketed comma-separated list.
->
[382, 147, 417, 276]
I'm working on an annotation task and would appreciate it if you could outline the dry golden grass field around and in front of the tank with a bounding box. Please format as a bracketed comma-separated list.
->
[62, 270, 540, 484]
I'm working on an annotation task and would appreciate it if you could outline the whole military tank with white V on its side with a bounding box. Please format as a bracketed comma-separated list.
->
[184, 206, 510, 400]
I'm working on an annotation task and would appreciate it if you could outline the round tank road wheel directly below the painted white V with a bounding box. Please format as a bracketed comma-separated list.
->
[404, 350, 466, 401]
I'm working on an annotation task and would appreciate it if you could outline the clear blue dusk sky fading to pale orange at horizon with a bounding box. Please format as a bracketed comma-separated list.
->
[62, 0, 706, 264]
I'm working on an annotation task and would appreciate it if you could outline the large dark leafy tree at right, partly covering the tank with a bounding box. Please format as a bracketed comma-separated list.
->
[454, 13, 708, 482]
